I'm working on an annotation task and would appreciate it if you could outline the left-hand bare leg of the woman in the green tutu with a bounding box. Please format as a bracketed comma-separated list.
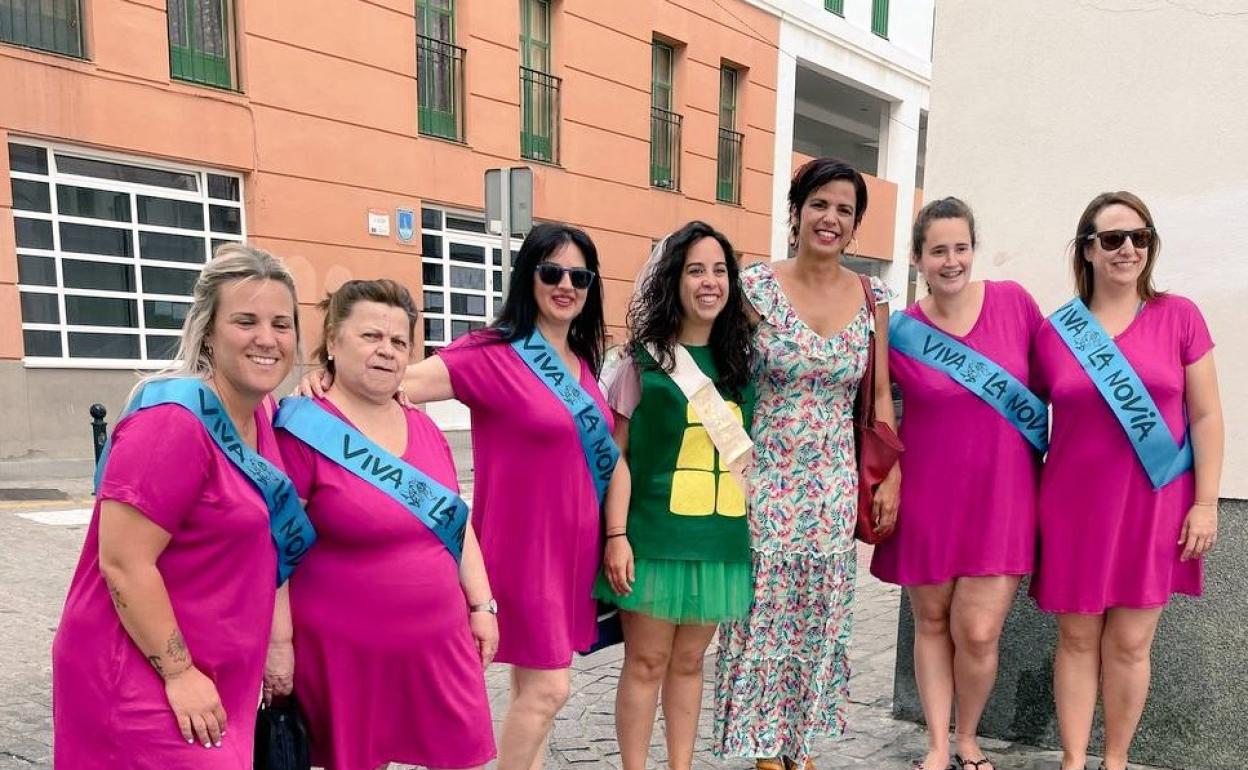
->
[615, 610, 676, 770]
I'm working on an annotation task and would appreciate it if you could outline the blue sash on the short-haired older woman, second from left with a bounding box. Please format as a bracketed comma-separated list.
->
[273, 398, 468, 563]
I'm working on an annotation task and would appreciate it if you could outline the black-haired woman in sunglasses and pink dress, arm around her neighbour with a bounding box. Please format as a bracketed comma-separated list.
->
[303, 223, 629, 770]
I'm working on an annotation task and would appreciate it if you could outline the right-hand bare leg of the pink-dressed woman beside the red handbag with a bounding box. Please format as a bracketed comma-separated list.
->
[950, 575, 1018, 770]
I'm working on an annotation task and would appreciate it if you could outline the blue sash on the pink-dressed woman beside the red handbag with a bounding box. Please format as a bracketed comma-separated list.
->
[889, 312, 1048, 454]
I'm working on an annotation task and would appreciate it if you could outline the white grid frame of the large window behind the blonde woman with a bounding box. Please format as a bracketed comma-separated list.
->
[10, 135, 247, 369]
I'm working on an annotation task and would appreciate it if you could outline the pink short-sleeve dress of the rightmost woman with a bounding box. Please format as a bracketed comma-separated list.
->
[1031, 295, 1213, 614]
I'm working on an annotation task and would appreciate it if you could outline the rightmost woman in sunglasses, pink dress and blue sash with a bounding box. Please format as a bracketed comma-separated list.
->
[1031, 192, 1223, 770]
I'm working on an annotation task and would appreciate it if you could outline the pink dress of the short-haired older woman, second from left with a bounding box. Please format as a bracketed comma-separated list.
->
[277, 398, 494, 770]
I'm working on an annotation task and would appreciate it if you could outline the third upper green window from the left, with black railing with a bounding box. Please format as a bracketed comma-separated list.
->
[416, 0, 466, 141]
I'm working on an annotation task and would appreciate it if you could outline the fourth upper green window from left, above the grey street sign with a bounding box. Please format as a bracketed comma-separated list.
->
[520, 0, 563, 163]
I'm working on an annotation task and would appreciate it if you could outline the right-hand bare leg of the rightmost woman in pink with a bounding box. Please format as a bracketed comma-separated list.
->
[1101, 607, 1162, 770]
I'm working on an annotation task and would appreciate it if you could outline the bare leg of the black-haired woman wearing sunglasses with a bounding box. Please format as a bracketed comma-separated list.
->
[498, 665, 572, 770]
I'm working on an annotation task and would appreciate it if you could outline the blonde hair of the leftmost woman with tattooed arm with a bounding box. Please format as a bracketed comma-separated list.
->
[127, 243, 302, 402]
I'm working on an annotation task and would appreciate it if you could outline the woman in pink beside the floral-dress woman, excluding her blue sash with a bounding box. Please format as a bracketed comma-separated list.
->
[871, 197, 1045, 770]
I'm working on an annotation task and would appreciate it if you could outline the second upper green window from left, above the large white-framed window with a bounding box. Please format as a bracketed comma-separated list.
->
[168, 0, 236, 89]
